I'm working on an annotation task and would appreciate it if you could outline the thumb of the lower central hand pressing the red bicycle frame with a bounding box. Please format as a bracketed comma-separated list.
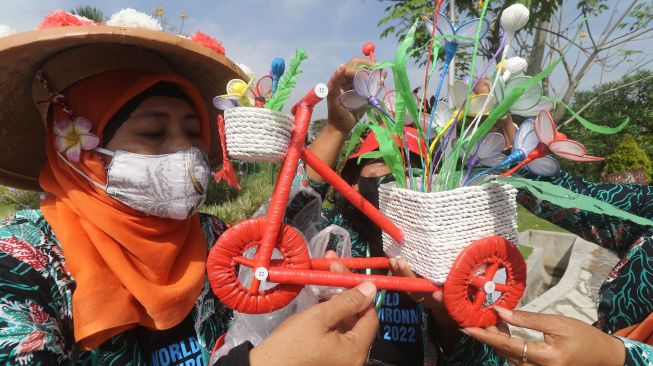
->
[317, 282, 376, 328]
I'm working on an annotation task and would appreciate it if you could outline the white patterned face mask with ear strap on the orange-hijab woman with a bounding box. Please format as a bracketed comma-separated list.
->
[62, 147, 210, 220]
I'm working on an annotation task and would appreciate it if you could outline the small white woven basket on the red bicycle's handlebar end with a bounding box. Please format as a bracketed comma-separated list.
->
[224, 107, 294, 163]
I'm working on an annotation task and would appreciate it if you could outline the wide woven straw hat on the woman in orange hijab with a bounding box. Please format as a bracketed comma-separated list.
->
[0, 26, 246, 190]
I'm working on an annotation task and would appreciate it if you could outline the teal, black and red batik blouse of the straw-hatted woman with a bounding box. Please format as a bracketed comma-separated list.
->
[0, 210, 232, 366]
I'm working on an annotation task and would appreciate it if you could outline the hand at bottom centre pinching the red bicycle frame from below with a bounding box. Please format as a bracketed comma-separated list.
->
[249, 282, 379, 366]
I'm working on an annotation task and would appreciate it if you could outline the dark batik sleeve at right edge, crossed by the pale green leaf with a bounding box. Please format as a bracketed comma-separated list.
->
[517, 171, 653, 365]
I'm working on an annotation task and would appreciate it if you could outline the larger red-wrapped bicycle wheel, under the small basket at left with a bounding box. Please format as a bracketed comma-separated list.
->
[206, 217, 310, 314]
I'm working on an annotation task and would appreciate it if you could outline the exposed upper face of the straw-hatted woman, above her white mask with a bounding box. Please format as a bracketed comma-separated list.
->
[105, 96, 208, 155]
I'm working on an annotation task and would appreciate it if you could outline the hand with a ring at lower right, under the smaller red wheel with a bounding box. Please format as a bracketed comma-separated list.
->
[464, 306, 626, 366]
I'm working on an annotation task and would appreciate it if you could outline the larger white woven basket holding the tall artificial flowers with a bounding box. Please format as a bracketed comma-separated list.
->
[379, 183, 517, 283]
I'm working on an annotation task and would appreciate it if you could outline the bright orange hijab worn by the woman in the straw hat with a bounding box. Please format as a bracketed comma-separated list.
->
[40, 69, 210, 350]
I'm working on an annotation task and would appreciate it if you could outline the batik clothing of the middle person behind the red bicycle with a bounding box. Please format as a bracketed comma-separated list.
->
[286, 161, 508, 366]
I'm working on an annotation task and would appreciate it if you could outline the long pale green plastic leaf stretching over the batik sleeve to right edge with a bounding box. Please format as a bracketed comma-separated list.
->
[497, 177, 653, 226]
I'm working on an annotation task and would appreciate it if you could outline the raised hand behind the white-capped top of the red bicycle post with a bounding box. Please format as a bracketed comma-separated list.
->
[327, 58, 375, 134]
